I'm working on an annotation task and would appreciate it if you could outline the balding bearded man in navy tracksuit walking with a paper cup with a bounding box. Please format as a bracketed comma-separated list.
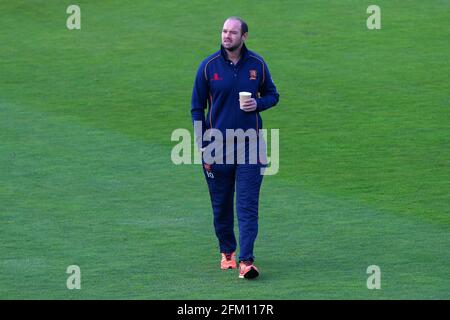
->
[191, 17, 279, 279]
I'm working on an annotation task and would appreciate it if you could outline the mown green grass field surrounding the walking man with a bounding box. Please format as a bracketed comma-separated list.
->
[0, 0, 450, 299]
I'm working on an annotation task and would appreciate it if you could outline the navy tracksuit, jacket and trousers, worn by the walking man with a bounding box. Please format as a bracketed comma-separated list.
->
[191, 44, 279, 261]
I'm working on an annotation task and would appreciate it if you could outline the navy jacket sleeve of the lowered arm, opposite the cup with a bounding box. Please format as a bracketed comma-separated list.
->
[191, 63, 209, 148]
